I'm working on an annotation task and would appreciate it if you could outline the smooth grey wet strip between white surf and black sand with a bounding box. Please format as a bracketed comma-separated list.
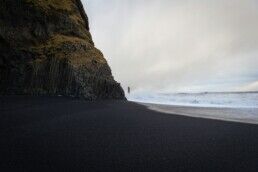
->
[137, 101, 258, 125]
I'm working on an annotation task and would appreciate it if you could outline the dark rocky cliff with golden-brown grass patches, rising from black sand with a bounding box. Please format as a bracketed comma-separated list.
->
[0, 0, 124, 100]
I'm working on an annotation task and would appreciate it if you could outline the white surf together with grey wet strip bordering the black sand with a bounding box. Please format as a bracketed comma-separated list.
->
[127, 92, 258, 124]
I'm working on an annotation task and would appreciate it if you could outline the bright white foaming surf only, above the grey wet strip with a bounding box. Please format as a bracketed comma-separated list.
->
[127, 92, 258, 108]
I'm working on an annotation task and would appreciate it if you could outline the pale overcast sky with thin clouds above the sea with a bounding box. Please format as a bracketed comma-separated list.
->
[83, 0, 258, 92]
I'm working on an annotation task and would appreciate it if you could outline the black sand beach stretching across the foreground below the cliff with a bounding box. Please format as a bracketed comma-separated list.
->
[0, 96, 258, 172]
